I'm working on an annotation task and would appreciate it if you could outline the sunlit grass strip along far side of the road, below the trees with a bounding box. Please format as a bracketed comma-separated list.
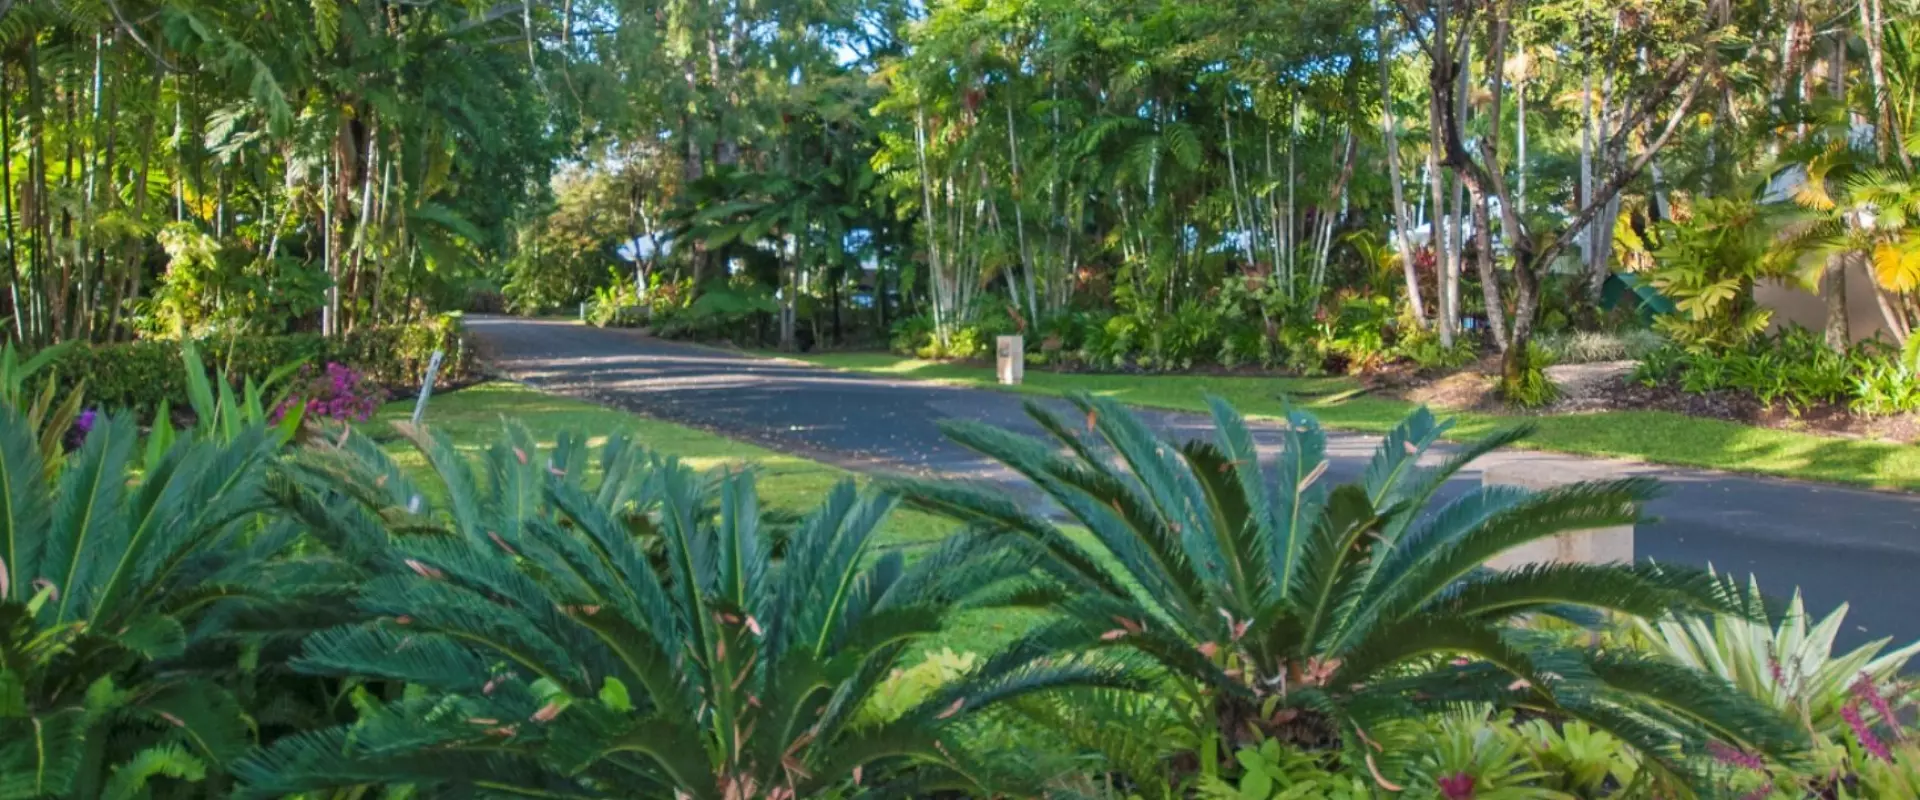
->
[797, 353, 1920, 489]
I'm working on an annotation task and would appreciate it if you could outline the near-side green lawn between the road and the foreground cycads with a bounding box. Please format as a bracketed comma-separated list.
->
[363, 382, 1037, 662]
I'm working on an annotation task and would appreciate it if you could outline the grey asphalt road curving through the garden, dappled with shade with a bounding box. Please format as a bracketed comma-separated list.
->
[468, 317, 1920, 643]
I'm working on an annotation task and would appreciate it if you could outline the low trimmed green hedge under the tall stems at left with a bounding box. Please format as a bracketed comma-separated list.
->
[50, 317, 476, 411]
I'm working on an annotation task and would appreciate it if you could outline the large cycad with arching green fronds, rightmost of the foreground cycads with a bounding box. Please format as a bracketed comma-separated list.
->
[899, 395, 1801, 782]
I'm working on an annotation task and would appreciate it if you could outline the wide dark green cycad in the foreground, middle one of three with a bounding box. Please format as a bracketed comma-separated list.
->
[240, 420, 1117, 798]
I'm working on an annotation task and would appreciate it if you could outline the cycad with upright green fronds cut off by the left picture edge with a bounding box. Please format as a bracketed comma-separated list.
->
[0, 407, 275, 800]
